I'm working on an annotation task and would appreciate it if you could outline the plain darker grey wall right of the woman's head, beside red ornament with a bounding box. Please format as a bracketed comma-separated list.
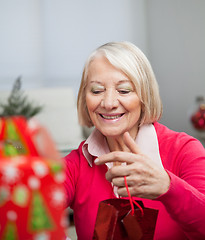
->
[147, 0, 205, 135]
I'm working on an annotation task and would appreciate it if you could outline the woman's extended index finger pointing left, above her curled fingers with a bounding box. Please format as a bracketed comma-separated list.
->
[94, 151, 136, 165]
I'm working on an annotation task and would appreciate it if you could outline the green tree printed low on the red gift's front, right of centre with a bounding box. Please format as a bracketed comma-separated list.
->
[29, 191, 54, 232]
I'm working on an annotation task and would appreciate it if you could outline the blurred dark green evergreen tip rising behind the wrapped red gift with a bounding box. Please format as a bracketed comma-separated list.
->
[0, 77, 42, 119]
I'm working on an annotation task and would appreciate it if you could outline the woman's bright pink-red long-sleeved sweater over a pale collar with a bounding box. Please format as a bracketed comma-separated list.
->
[65, 123, 205, 240]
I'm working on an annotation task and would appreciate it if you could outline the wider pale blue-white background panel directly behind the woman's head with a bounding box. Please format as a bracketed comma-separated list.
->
[42, 0, 146, 94]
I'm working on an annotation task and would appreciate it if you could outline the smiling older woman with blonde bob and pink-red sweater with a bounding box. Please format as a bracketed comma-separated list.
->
[65, 42, 205, 240]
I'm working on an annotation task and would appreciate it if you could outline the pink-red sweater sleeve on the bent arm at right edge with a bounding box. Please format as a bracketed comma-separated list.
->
[156, 138, 205, 240]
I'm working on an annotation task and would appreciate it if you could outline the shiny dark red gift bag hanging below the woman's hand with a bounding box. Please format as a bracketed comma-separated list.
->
[93, 198, 158, 240]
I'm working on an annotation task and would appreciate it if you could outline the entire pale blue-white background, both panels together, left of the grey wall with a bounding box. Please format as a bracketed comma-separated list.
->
[0, 0, 147, 94]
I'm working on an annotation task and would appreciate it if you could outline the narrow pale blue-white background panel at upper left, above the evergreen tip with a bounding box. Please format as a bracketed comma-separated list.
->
[0, 0, 42, 90]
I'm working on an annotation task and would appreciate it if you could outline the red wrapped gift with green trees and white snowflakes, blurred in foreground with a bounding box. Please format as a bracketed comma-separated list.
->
[0, 117, 65, 240]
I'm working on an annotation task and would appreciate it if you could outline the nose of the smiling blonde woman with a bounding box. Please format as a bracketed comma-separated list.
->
[101, 89, 119, 110]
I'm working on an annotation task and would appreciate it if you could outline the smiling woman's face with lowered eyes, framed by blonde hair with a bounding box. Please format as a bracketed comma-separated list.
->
[86, 56, 141, 138]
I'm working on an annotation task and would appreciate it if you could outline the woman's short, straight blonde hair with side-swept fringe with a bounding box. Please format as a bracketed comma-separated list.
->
[77, 42, 162, 127]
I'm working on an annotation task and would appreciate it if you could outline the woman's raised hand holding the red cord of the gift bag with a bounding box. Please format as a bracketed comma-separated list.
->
[95, 132, 170, 199]
